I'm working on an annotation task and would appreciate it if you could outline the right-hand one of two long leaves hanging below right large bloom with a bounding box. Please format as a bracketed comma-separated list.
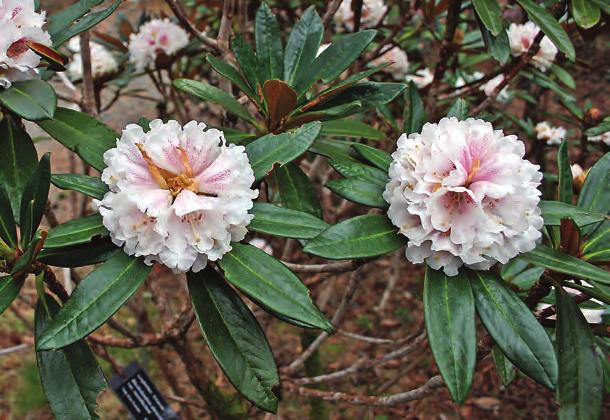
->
[468, 270, 558, 389]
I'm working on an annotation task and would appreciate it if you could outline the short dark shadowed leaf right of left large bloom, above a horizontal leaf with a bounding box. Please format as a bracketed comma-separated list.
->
[273, 163, 322, 219]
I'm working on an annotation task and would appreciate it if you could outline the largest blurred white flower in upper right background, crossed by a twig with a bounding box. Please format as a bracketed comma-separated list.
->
[508, 22, 557, 71]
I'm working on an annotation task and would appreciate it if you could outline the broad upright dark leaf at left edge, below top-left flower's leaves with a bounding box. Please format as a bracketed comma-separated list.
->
[0, 115, 38, 223]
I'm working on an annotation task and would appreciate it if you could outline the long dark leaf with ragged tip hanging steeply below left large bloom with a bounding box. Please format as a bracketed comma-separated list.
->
[187, 268, 280, 412]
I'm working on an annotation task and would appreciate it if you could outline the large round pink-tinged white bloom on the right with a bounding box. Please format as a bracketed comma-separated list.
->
[383, 118, 543, 276]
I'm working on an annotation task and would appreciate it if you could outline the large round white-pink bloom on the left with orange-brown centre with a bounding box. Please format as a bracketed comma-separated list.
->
[95, 120, 258, 273]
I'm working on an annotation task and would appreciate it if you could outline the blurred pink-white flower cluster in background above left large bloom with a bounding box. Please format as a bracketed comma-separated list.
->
[129, 19, 189, 71]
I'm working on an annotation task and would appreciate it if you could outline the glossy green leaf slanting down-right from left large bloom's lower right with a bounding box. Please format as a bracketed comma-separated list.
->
[219, 244, 333, 332]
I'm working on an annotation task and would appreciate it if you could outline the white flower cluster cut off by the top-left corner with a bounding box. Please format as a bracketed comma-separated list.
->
[0, 0, 51, 88]
